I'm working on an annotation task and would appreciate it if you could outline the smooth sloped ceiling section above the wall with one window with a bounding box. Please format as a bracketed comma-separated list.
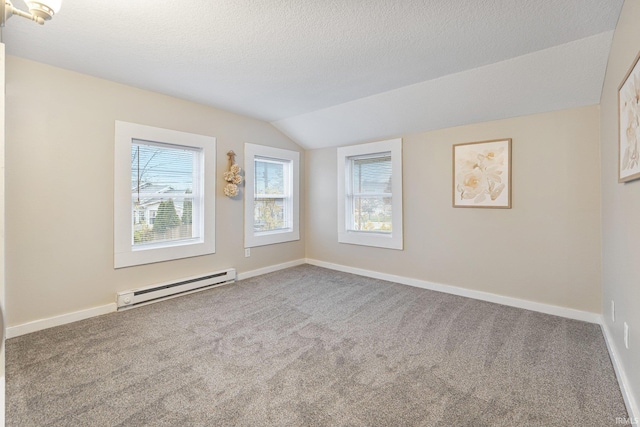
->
[273, 31, 613, 149]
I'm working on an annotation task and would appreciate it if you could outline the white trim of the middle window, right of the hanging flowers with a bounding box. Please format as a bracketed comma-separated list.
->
[244, 143, 300, 248]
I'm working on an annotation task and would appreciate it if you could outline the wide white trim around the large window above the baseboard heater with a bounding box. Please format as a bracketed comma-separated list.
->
[113, 121, 216, 268]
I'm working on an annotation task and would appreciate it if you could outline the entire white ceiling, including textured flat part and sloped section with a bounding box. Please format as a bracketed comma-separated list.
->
[2, 0, 623, 148]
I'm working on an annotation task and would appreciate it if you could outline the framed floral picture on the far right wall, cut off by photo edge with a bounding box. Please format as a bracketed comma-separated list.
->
[618, 53, 640, 182]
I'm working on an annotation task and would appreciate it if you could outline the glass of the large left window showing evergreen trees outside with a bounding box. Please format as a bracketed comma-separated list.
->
[131, 140, 199, 246]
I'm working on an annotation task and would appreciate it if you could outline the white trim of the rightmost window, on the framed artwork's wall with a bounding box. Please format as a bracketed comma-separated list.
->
[338, 138, 403, 250]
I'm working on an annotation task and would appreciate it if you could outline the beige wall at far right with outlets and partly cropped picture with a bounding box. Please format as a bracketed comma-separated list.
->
[600, 0, 640, 417]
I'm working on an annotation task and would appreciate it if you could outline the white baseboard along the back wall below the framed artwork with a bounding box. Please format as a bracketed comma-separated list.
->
[306, 258, 602, 324]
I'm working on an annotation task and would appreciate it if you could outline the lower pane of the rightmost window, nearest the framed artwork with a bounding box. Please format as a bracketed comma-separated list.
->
[351, 196, 392, 233]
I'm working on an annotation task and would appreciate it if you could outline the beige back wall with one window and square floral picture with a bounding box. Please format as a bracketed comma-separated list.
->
[306, 106, 601, 313]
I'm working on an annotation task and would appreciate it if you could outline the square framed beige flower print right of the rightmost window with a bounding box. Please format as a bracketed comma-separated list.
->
[453, 138, 511, 209]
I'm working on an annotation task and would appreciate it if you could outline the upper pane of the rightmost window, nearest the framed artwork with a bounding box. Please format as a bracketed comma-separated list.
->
[351, 153, 391, 194]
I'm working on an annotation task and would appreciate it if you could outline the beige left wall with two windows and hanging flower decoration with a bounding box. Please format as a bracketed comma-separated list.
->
[6, 57, 304, 326]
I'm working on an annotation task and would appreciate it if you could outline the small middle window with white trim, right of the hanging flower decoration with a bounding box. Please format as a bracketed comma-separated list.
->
[244, 144, 300, 248]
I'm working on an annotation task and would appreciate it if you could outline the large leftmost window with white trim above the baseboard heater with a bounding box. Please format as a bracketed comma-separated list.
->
[114, 122, 215, 268]
